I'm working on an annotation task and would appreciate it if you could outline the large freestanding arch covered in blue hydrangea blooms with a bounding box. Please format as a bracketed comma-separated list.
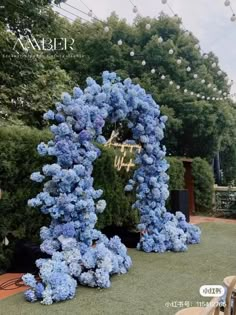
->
[23, 71, 200, 304]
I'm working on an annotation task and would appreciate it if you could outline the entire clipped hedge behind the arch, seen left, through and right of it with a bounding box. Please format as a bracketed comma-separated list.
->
[0, 126, 191, 271]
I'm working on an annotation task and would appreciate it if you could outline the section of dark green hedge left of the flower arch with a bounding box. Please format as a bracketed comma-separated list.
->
[0, 126, 50, 272]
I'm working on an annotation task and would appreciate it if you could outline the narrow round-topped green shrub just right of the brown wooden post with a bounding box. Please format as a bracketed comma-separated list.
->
[192, 158, 214, 211]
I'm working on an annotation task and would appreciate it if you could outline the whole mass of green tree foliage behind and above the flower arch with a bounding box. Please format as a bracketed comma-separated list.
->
[0, 8, 236, 175]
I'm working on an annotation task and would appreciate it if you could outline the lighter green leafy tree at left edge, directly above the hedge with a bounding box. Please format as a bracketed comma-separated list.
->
[0, 21, 74, 128]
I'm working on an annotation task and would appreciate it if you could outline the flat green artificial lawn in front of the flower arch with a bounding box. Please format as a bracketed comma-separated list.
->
[0, 223, 236, 315]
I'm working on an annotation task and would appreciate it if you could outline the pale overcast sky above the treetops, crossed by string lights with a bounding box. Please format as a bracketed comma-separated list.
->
[55, 0, 236, 93]
